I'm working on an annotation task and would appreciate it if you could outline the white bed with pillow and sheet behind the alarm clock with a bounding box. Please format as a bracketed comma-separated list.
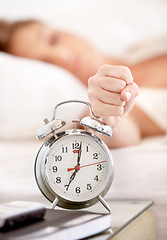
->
[0, 51, 167, 240]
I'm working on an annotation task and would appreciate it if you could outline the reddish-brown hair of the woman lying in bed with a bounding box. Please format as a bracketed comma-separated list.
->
[0, 20, 38, 52]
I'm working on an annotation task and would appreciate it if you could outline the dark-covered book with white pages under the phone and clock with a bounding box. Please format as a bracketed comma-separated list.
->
[0, 209, 111, 240]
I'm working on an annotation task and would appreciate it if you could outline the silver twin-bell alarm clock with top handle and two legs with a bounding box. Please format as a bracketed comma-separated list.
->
[34, 100, 114, 211]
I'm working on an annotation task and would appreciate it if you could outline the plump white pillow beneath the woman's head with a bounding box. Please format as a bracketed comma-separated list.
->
[0, 53, 87, 139]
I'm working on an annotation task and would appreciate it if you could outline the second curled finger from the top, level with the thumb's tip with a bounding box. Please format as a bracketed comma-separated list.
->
[88, 75, 126, 92]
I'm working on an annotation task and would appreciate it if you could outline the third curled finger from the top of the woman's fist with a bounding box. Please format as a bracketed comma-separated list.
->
[88, 88, 125, 106]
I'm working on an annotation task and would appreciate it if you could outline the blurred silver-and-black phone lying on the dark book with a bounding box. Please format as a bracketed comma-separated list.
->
[0, 201, 45, 231]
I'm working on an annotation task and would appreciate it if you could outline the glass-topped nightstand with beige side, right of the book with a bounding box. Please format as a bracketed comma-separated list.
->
[85, 200, 156, 240]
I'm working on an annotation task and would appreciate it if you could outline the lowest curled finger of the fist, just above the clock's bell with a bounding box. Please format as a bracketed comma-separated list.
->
[92, 99, 124, 118]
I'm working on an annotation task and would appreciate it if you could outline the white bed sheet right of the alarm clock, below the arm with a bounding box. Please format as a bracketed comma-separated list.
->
[108, 137, 167, 204]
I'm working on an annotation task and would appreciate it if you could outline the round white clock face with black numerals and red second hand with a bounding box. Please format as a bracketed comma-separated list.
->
[45, 134, 113, 202]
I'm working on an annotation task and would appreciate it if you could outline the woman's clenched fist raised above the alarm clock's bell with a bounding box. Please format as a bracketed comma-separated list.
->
[88, 65, 139, 127]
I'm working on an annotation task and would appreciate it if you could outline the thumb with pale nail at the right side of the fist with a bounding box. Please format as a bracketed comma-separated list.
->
[121, 83, 139, 101]
